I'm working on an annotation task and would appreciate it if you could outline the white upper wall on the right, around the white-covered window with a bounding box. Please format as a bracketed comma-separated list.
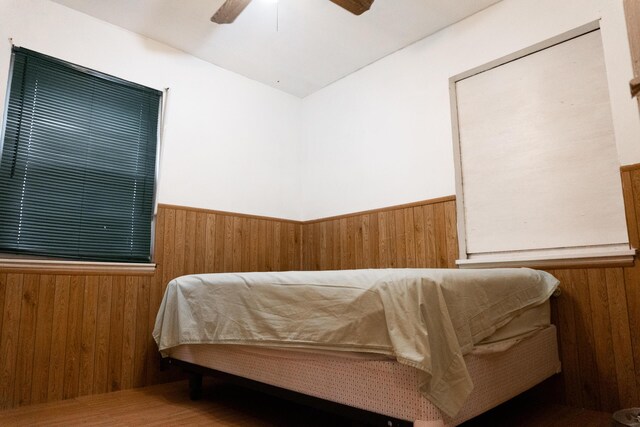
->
[302, 0, 640, 219]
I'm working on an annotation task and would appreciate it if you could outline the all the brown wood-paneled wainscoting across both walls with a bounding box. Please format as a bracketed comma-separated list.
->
[0, 165, 640, 412]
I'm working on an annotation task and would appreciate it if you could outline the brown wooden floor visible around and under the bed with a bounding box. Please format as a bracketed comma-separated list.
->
[0, 380, 611, 427]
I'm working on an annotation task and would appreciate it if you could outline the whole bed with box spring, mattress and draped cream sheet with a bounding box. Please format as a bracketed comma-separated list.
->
[153, 269, 560, 427]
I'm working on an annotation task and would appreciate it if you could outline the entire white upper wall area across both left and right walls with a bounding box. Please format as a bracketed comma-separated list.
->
[0, 0, 640, 219]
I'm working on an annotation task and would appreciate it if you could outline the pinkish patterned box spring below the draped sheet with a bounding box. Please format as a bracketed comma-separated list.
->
[168, 325, 560, 427]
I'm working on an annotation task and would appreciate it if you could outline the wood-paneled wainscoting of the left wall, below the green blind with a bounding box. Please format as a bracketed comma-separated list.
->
[0, 205, 302, 409]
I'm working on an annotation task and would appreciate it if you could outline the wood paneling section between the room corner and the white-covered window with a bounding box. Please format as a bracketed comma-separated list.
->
[302, 196, 458, 270]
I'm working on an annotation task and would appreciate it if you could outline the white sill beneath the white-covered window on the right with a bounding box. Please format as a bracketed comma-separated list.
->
[456, 249, 636, 268]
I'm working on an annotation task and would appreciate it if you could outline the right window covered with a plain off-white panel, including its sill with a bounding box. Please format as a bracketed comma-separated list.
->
[452, 24, 634, 266]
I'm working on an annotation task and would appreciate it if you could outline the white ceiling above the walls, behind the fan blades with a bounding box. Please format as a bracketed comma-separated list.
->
[53, 0, 499, 98]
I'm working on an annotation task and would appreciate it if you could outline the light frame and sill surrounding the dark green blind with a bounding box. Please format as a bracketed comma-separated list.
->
[0, 44, 164, 274]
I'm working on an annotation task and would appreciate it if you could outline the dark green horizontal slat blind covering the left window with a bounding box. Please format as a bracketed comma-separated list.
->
[0, 48, 161, 262]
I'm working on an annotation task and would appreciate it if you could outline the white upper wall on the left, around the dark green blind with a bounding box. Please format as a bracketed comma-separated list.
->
[0, 0, 301, 219]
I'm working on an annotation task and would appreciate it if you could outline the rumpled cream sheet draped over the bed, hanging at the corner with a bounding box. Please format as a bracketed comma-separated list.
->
[153, 269, 558, 416]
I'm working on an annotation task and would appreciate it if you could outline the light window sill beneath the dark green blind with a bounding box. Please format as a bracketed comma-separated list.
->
[0, 258, 156, 275]
